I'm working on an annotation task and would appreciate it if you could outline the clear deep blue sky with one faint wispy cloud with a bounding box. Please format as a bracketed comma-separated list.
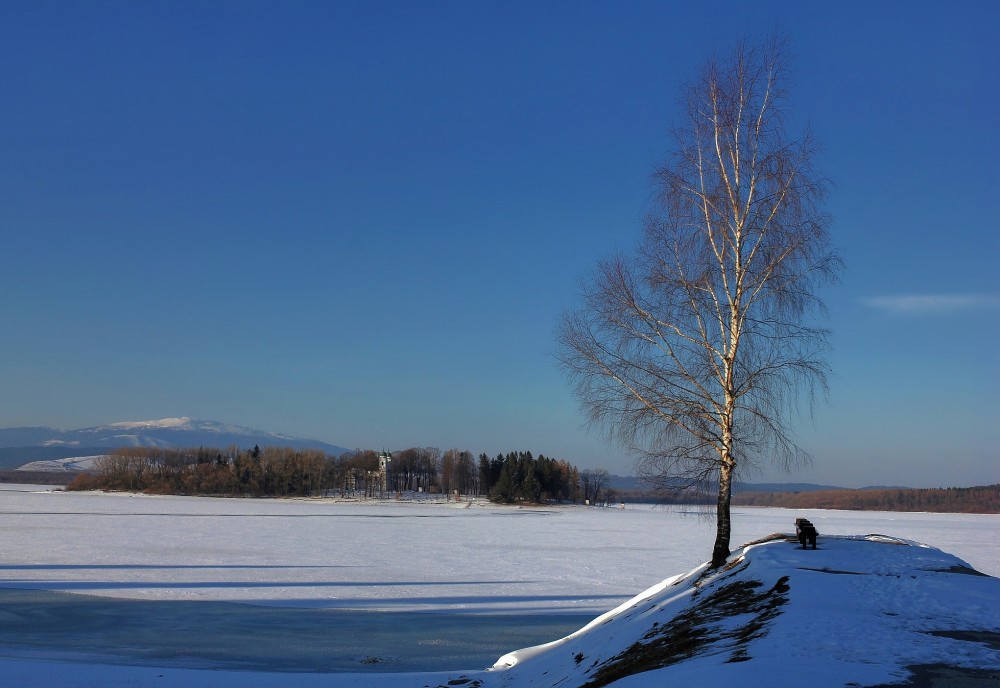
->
[0, 1, 1000, 486]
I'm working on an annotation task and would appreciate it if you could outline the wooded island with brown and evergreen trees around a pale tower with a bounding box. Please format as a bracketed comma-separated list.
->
[68, 446, 614, 504]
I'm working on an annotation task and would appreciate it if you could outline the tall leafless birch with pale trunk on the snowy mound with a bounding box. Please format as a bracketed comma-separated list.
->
[557, 39, 841, 566]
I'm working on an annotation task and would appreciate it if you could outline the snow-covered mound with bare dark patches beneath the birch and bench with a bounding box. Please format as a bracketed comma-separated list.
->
[482, 535, 1000, 688]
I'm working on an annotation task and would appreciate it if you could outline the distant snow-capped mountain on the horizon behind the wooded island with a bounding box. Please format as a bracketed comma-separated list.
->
[0, 418, 350, 468]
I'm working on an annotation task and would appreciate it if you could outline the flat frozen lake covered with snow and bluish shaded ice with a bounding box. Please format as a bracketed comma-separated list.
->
[0, 486, 1000, 687]
